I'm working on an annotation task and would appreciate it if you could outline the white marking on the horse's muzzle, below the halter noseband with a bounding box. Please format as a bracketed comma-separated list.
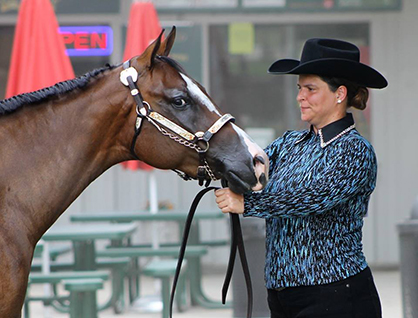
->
[232, 124, 269, 191]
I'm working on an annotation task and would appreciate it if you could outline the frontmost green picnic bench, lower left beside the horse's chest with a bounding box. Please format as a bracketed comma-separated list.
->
[24, 271, 109, 318]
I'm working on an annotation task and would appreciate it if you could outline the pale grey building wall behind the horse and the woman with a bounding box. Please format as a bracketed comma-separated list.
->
[0, 0, 418, 266]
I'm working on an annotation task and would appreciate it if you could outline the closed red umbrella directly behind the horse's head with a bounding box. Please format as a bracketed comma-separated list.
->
[122, 2, 161, 170]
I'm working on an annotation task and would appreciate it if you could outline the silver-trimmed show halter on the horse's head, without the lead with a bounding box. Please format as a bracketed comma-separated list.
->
[120, 60, 235, 185]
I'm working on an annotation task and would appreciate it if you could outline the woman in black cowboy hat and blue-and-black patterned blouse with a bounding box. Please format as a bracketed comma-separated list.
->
[215, 39, 387, 318]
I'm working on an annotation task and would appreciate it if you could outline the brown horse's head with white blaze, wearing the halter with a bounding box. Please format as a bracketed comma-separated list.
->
[121, 27, 269, 193]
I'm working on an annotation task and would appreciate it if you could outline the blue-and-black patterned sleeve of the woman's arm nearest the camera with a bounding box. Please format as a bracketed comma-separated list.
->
[244, 140, 377, 218]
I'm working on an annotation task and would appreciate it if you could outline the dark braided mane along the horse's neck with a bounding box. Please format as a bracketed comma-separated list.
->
[0, 65, 115, 115]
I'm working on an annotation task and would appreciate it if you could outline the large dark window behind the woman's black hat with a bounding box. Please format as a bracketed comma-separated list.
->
[209, 24, 370, 138]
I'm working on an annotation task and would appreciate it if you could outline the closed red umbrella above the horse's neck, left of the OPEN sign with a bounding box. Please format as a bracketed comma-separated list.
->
[6, 0, 74, 98]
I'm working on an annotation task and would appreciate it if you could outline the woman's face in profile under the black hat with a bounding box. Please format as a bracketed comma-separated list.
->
[296, 74, 345, 130]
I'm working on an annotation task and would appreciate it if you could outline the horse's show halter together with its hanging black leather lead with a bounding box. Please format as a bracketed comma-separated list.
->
[120, 60, 253, 318]
